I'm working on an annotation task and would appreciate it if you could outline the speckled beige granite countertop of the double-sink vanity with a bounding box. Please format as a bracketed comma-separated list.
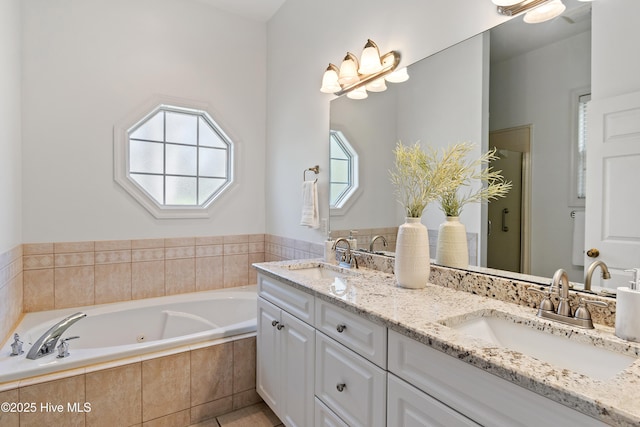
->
[254, 260, 640, 426]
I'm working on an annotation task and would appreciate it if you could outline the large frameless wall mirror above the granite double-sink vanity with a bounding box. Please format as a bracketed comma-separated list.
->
[330, 0, 616, 287]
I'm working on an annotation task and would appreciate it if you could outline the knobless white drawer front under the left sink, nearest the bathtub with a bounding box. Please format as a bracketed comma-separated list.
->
[258, 274, 314, 325]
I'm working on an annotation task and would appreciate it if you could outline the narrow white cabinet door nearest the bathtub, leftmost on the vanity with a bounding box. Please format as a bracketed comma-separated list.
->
[256, 298, 281, 413]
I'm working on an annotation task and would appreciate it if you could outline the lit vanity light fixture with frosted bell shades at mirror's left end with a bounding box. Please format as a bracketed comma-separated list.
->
[320, 39, 409, 99]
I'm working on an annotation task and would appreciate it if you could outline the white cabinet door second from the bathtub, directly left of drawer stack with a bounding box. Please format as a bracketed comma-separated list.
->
[276, 311, 315, 427]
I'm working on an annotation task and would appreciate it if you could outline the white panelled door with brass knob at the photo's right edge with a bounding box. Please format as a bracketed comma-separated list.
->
[584, 92, 640, 288]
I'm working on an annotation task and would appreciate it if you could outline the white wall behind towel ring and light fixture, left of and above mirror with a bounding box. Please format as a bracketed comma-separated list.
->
[266, 0, 504, 241]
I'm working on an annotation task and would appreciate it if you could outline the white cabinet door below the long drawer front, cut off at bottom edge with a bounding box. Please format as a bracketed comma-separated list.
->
[387, 374, 479, 427]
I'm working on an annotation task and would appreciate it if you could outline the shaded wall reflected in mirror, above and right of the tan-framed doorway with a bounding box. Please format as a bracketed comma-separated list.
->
[490, 32, 591, 282]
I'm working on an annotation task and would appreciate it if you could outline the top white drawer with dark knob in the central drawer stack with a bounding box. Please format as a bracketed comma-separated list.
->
[315, 298, 387, 369]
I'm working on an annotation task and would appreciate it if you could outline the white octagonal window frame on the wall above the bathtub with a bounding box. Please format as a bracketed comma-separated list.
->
[113, 96, 235, 219]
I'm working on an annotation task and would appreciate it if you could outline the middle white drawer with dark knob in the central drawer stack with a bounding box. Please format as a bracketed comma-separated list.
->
[315, 332, 387, 427]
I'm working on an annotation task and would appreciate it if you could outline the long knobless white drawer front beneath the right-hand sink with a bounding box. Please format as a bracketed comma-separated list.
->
[389, 331, 604, 427]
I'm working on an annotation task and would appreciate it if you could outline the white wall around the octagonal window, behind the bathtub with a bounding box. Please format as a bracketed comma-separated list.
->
[20, 0, 266, 242]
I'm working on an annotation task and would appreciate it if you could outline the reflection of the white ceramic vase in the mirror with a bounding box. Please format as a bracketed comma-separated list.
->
[436, 216, 469, 268]
